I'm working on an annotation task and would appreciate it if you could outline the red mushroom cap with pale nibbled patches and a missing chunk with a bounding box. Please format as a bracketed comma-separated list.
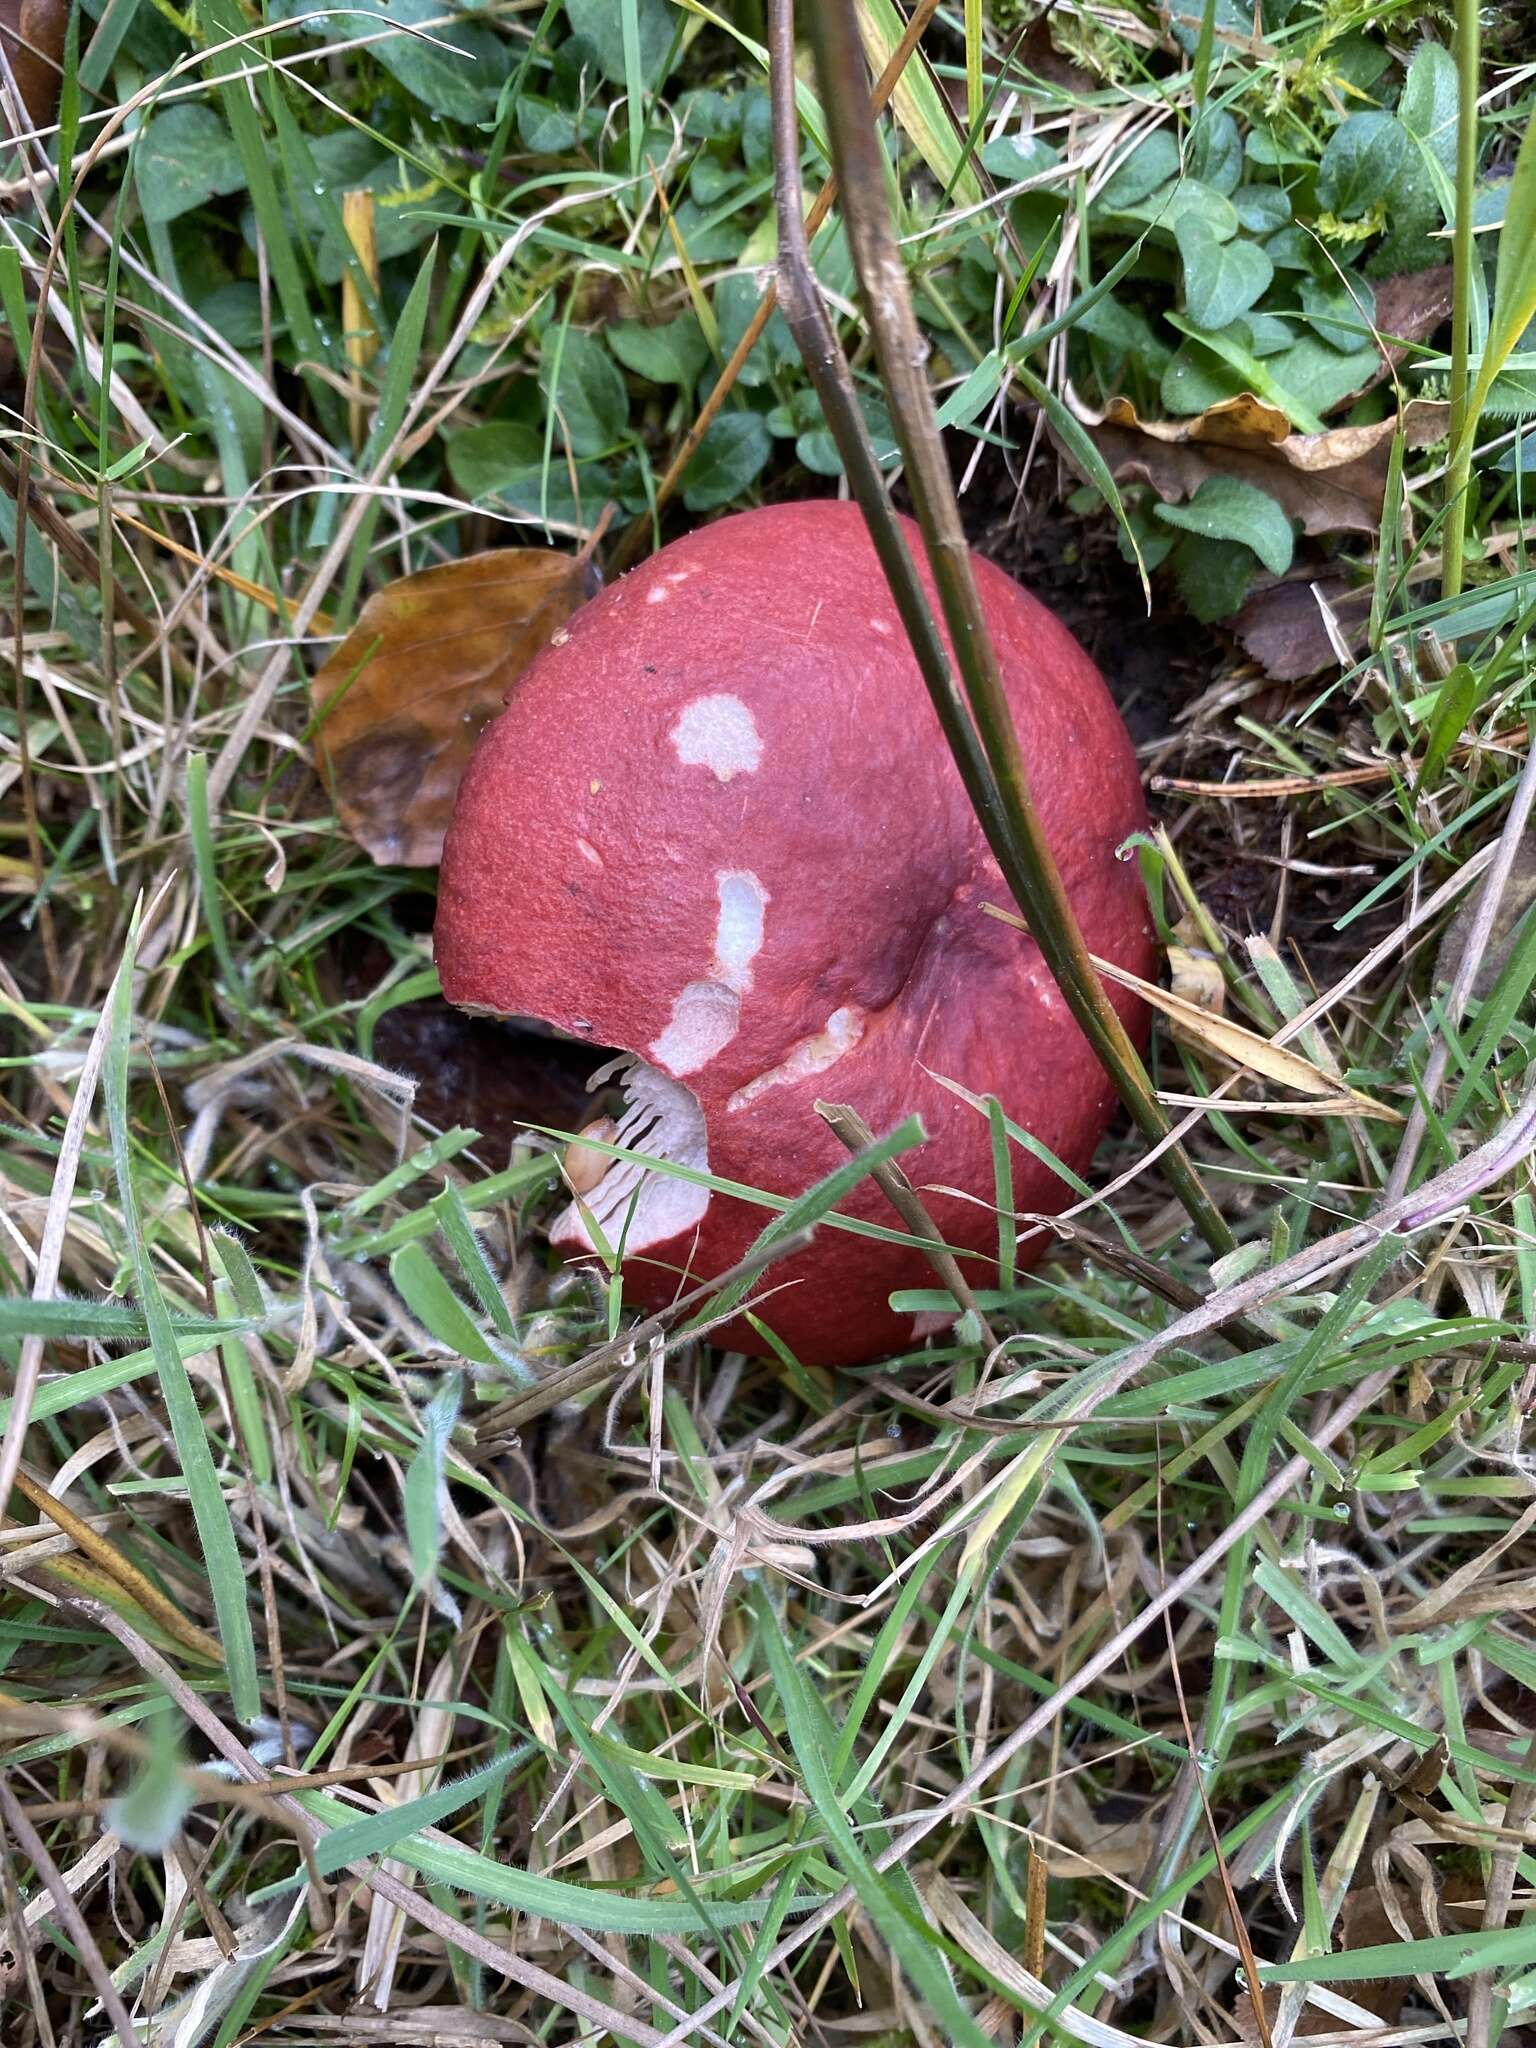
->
[436, 502, 1153, 1364]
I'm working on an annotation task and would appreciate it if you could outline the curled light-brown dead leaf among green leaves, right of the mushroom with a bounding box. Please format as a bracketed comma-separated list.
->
[1063, 391, 1448, 535]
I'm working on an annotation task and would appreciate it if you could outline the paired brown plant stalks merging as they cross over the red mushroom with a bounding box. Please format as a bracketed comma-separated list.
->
[770, 0, 1235, 1253]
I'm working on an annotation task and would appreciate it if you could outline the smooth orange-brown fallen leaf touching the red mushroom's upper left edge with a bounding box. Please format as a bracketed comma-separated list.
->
[309, 547, 592, 868]
